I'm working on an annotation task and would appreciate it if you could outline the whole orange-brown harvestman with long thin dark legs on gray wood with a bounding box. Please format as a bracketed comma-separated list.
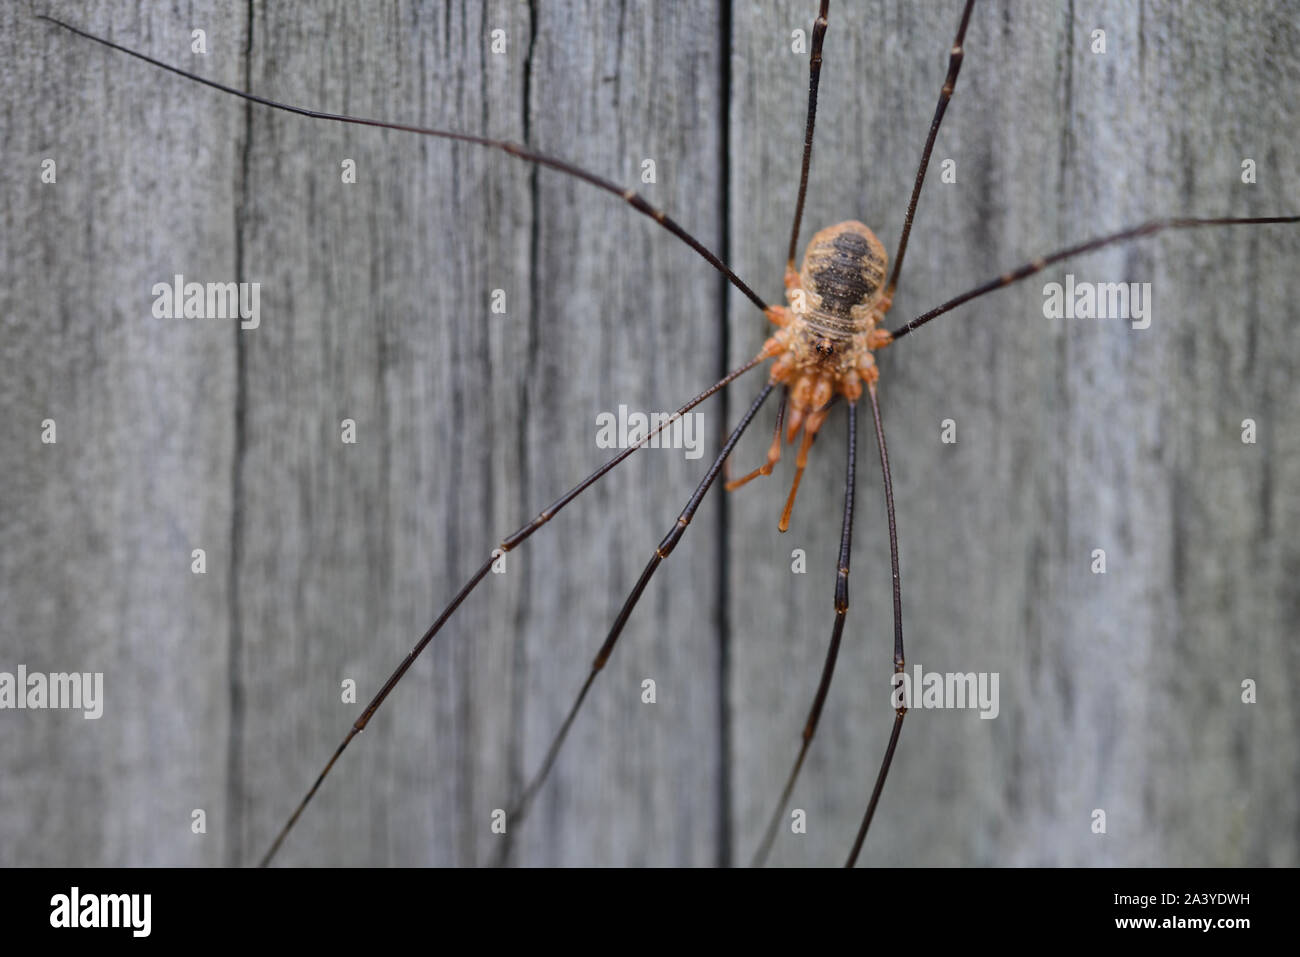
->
[35, 0, 1300, 863]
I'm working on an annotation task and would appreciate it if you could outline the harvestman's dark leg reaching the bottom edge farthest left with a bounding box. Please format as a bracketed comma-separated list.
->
[259, 355, 771, 867]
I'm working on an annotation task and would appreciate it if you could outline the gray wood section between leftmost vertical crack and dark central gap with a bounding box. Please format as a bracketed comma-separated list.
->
[227, 4, 720, 863]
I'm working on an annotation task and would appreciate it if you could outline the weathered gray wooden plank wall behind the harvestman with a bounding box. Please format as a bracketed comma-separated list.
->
[0, 0, 1300, 865]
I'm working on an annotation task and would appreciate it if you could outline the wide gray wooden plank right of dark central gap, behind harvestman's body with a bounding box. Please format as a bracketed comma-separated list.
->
[731, 3, 1300, 865]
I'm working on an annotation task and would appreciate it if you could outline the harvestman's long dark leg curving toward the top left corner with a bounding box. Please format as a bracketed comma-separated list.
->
[38, 14, 767, 312]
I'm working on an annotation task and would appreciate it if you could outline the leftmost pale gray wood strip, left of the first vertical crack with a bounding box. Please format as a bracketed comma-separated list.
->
[0, 4, 241, 865]
